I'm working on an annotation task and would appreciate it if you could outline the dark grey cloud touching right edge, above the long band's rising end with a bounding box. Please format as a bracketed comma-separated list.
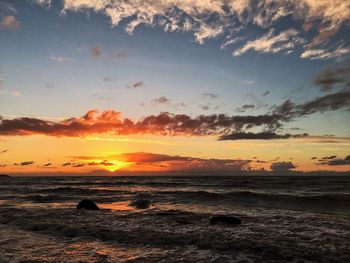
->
[313, 61, 350, 91]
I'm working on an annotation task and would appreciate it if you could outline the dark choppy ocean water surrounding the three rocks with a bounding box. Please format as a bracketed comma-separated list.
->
[0, 176, 350, 263]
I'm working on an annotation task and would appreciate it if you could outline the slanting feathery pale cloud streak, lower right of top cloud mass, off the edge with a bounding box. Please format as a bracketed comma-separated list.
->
[233, 29, 304, 56]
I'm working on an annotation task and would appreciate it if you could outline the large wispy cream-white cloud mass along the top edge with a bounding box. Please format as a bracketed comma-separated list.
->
[34, 0, 350, 58]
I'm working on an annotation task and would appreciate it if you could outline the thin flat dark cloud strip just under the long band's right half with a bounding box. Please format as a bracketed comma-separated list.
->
[219, 132, 308, 141]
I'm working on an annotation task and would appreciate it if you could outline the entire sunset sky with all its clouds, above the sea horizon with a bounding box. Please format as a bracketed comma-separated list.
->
[0, 0, 350, 175]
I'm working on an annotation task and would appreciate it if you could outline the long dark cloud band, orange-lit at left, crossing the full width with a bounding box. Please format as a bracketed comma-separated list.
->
[0, 91, 350, 138]
